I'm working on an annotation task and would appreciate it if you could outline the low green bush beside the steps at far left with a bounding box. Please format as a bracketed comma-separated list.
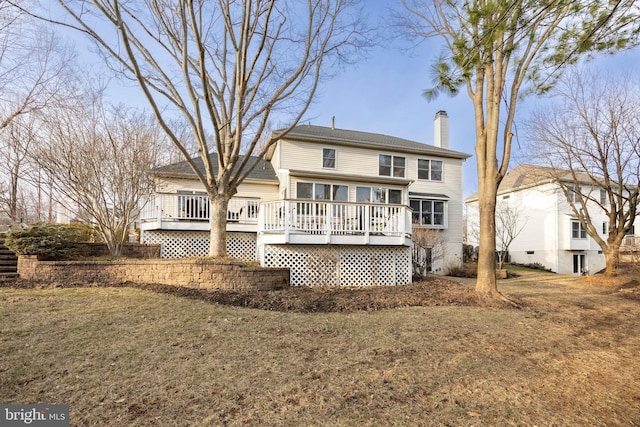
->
[5, 224, 95, 259]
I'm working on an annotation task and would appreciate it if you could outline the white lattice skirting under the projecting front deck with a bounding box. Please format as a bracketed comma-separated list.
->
[262, 245, 411, 286]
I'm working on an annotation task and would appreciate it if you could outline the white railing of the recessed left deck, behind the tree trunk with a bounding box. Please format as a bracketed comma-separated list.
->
[140, 193, 260, 224]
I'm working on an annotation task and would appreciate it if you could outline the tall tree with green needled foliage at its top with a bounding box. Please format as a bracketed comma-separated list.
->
[397, 0, 639, 299]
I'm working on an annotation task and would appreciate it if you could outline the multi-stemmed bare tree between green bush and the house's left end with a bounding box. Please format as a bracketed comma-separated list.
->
[35, 97, 164, 255]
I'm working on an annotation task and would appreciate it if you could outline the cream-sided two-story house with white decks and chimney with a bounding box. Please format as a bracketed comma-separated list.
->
[140, 112, 469, 285]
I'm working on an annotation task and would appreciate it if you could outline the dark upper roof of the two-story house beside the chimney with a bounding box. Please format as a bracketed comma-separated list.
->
[274, 125, 471, 160]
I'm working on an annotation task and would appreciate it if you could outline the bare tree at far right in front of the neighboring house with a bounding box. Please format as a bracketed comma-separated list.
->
[527, 70, 640, 275]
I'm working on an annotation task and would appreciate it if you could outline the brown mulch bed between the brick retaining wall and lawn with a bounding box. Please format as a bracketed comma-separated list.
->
[2, 277, 513, 313]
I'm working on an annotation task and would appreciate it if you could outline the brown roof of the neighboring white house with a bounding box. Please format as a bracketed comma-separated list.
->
[465, 164, 589, 202]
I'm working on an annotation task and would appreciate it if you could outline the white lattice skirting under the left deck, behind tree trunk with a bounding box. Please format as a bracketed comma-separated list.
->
[142, 230, 256, 261]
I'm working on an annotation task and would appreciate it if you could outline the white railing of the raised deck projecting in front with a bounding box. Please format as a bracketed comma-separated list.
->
[258, 200, 411, 236]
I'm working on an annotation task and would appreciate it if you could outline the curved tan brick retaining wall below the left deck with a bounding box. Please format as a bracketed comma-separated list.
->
[18, 256, 289, 290]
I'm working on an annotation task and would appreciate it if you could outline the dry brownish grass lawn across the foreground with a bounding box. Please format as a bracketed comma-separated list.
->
[0, 274, 640, 426]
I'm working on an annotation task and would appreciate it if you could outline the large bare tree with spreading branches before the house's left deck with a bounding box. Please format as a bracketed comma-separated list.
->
[28, 0, 368, 256]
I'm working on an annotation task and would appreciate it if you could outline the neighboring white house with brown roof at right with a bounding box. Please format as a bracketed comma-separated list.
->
[465, 165, 635, 274]
